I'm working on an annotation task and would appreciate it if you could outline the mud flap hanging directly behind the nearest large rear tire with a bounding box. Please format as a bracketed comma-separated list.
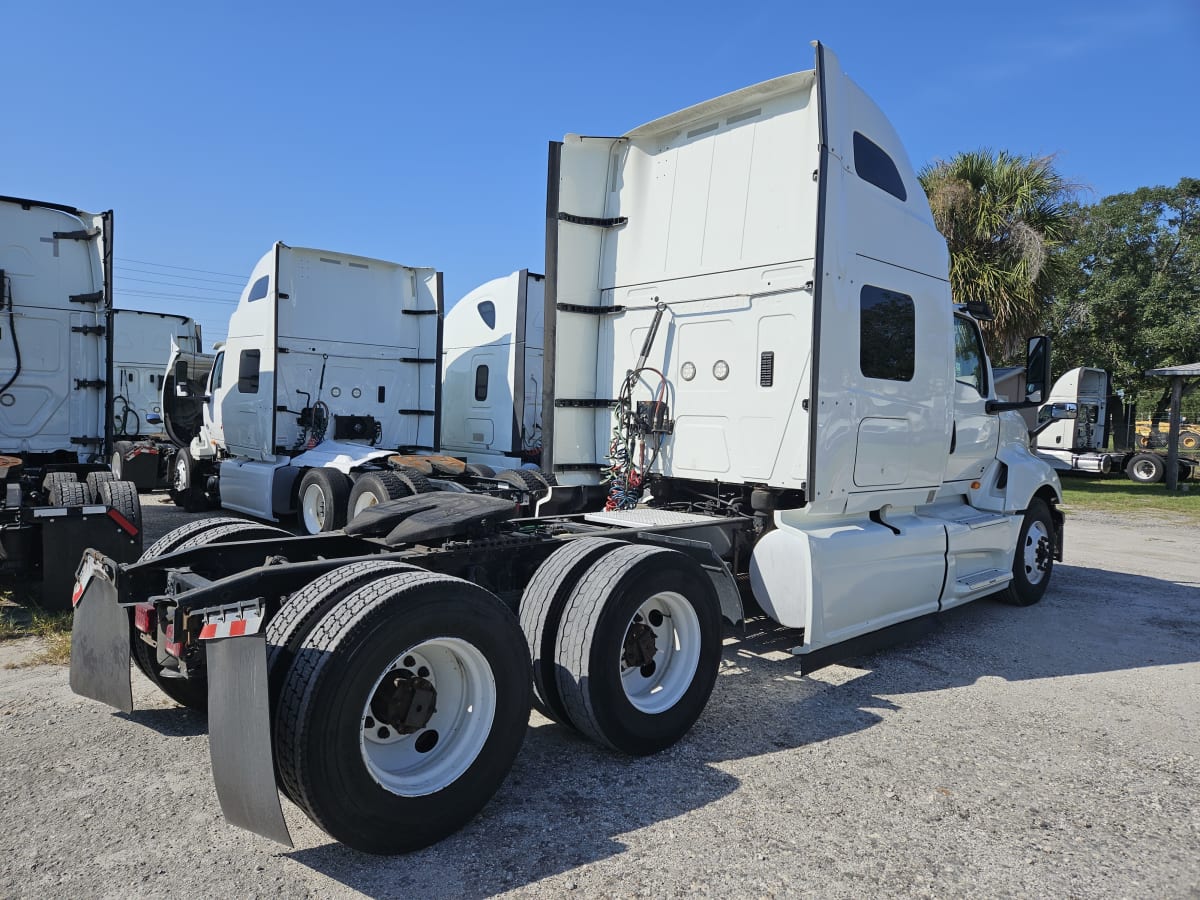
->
[205, 634, 293, 847]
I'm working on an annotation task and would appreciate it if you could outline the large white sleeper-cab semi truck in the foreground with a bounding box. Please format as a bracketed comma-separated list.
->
[71, 44, 1063, 853]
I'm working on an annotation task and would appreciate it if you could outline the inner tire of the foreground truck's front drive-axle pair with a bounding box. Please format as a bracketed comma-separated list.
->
[520, 538, 629, 726]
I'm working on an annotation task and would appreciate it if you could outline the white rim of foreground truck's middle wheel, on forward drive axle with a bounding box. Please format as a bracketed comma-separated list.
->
[618, 590, 701, 715]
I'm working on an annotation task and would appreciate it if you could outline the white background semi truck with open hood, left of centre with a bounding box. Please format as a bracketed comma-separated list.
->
[163, 244, 548, 534]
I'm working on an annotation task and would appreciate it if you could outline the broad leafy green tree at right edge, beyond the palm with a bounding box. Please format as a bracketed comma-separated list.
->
[1049, 178, 1200, 415]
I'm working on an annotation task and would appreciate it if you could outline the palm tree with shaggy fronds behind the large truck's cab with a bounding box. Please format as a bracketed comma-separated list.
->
[918, 150, 1075, 361]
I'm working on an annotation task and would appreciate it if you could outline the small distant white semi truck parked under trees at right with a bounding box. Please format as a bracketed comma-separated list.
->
[1034, 366, 1200, 485]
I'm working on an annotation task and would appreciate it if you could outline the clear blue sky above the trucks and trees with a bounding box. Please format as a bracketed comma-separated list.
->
[0, 0, 1200, 342]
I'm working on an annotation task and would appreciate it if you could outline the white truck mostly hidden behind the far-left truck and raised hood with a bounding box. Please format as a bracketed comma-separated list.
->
[109, 310, 204, 491]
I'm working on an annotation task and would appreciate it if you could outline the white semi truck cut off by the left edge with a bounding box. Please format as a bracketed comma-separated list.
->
[0, 197, 142, 608]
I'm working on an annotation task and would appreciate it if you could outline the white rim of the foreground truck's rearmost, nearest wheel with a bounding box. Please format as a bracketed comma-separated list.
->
[359, 637, 496, 797]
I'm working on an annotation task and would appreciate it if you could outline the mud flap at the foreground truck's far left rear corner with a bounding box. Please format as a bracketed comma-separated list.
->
[71, 550, 133, 713]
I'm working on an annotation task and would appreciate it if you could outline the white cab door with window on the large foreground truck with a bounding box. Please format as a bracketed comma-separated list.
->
[946, 314, 1000, 481]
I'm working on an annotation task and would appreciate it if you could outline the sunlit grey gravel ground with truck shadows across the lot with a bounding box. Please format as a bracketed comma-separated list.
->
[0, 497, 1200, 898]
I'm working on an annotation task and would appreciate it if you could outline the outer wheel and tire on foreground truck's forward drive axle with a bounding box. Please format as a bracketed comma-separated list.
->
[554, 546, 721, 756]
